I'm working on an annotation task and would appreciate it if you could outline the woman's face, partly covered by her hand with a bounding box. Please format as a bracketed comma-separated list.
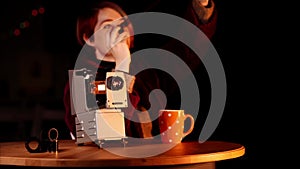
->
[94, 8, 130, 56]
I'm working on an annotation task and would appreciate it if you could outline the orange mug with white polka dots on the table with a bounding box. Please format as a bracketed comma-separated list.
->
[158, 109, 195, 144]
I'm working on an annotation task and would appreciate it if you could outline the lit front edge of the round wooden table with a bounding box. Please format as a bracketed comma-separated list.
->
[0, 141, 245, 167]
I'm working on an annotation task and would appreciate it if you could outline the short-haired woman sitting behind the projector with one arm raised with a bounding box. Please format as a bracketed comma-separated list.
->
[64, 0, 216, 138]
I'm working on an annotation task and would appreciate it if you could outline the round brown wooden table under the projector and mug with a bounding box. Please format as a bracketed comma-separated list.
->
[0, 140, 245, 169]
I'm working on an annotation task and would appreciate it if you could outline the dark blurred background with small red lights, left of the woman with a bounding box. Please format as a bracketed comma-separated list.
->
[0, 0, 77, 141]
